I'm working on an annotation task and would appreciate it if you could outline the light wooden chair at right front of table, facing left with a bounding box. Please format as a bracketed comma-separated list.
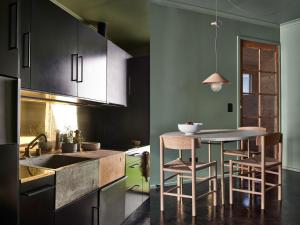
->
[229, 133, 282, 209]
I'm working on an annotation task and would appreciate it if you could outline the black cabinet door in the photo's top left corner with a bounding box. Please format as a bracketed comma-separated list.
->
[0, 0, 19, 77]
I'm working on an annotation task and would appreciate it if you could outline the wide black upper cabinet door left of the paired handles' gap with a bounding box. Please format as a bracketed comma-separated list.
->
[22, 0, 77, 96]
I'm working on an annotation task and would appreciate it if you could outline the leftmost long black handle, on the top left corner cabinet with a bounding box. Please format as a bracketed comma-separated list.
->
[8, 2, 18, 50]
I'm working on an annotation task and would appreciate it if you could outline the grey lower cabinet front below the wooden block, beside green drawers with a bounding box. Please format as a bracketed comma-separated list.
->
[99, 177, 127, 225]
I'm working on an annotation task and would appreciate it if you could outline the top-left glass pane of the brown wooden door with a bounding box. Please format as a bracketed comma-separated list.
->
[242, 47, 259, 71]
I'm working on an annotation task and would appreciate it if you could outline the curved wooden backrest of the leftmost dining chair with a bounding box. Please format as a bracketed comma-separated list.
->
[160, 135, 200, 150]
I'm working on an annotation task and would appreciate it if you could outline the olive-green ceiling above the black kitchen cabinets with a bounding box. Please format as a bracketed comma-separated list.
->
[56, 0, 150, 53]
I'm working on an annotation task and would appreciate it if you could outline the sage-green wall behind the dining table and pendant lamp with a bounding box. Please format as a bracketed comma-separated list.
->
[150, 4, 280, 185]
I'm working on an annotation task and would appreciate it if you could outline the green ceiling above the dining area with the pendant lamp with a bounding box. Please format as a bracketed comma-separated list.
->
[153, 0, 300, 25]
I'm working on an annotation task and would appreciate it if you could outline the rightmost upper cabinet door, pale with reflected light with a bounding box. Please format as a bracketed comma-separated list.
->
[107, 40, 131, 106]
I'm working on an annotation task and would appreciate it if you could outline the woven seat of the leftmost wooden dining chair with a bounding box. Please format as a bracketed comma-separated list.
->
[163, 159, 216, 173]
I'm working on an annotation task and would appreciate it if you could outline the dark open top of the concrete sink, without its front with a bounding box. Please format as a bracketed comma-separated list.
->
[20, 155, 90, 169]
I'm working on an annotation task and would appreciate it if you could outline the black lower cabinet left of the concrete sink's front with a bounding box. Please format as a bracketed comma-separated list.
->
[20, 175, 55, 225]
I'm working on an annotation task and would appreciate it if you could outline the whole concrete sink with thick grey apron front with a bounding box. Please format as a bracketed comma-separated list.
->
[20, 155, 99, 209]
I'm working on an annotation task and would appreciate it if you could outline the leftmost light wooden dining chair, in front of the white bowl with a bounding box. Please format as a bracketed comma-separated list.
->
[160, 135, 217, 216]
